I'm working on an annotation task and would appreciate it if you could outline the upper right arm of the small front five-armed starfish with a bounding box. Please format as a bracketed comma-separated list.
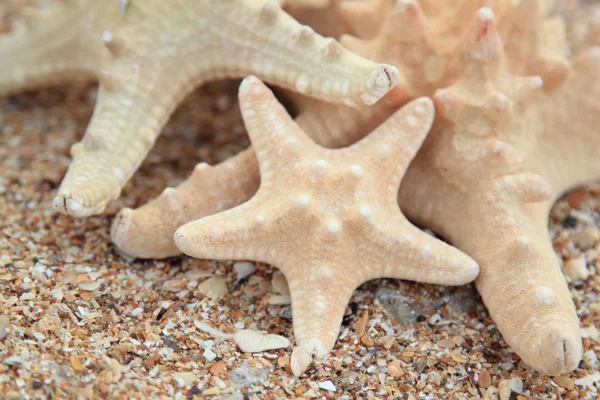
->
[348, 97, 435, 191]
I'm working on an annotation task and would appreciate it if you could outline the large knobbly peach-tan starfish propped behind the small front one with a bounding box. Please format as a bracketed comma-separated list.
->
[113, 0, 600, 374]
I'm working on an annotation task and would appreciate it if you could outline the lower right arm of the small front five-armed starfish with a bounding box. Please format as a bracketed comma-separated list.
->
[364, 215, 479, 286]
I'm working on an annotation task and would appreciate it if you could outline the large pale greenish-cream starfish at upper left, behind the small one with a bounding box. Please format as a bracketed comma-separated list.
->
[0, 0, 397, 216]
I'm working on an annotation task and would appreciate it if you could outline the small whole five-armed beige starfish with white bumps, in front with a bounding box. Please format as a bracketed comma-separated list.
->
[175, 77, 479, 375]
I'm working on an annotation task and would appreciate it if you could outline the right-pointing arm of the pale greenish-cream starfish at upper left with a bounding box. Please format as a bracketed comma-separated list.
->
[212, 0, 398, 106]
